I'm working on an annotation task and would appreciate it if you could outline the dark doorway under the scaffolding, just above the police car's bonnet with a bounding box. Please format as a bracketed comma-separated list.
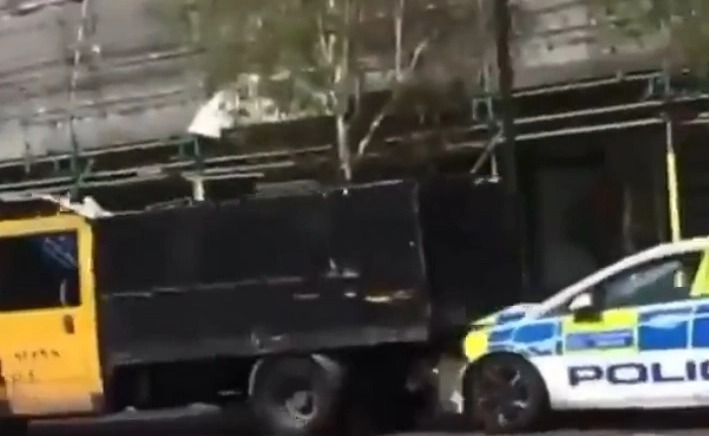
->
[521, 140, 623, 301]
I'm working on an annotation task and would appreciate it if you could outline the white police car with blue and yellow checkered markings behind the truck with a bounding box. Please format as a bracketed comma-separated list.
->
[461, 237, 709, 433]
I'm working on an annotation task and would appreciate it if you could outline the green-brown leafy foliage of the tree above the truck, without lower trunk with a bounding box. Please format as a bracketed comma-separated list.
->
[153, 0, 489, 118]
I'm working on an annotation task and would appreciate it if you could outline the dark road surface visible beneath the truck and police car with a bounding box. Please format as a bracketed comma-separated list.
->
[26, 405, 709, 436]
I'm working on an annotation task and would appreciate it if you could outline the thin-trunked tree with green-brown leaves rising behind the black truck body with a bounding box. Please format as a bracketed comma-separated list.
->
[153, 0, 484, 180]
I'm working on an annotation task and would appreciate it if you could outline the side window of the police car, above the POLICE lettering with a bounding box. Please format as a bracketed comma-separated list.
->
[597, 252, 701, 309]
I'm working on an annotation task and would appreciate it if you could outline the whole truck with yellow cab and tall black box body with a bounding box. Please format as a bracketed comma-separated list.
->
[0, 177, 520, 435]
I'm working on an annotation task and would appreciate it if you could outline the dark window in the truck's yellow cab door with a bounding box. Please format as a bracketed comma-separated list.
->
[0, 232, 80, 312]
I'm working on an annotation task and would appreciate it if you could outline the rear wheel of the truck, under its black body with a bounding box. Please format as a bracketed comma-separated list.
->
[251, 357, 342, 435]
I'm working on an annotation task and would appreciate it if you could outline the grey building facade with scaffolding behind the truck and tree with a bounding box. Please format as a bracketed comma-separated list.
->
[0, 0, 709, 298]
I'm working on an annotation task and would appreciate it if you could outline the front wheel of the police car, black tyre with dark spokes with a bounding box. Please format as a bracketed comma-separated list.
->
[464, 354, 549, 434]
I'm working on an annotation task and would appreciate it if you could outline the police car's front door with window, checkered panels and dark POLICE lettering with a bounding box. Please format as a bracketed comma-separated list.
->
[559, 251, 709, 409]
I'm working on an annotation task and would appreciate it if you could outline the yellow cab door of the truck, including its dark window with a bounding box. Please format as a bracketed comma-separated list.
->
[0, 215, 103, 416]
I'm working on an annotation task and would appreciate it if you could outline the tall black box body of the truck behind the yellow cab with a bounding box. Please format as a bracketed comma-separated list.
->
[94, 177, 520, 368]
